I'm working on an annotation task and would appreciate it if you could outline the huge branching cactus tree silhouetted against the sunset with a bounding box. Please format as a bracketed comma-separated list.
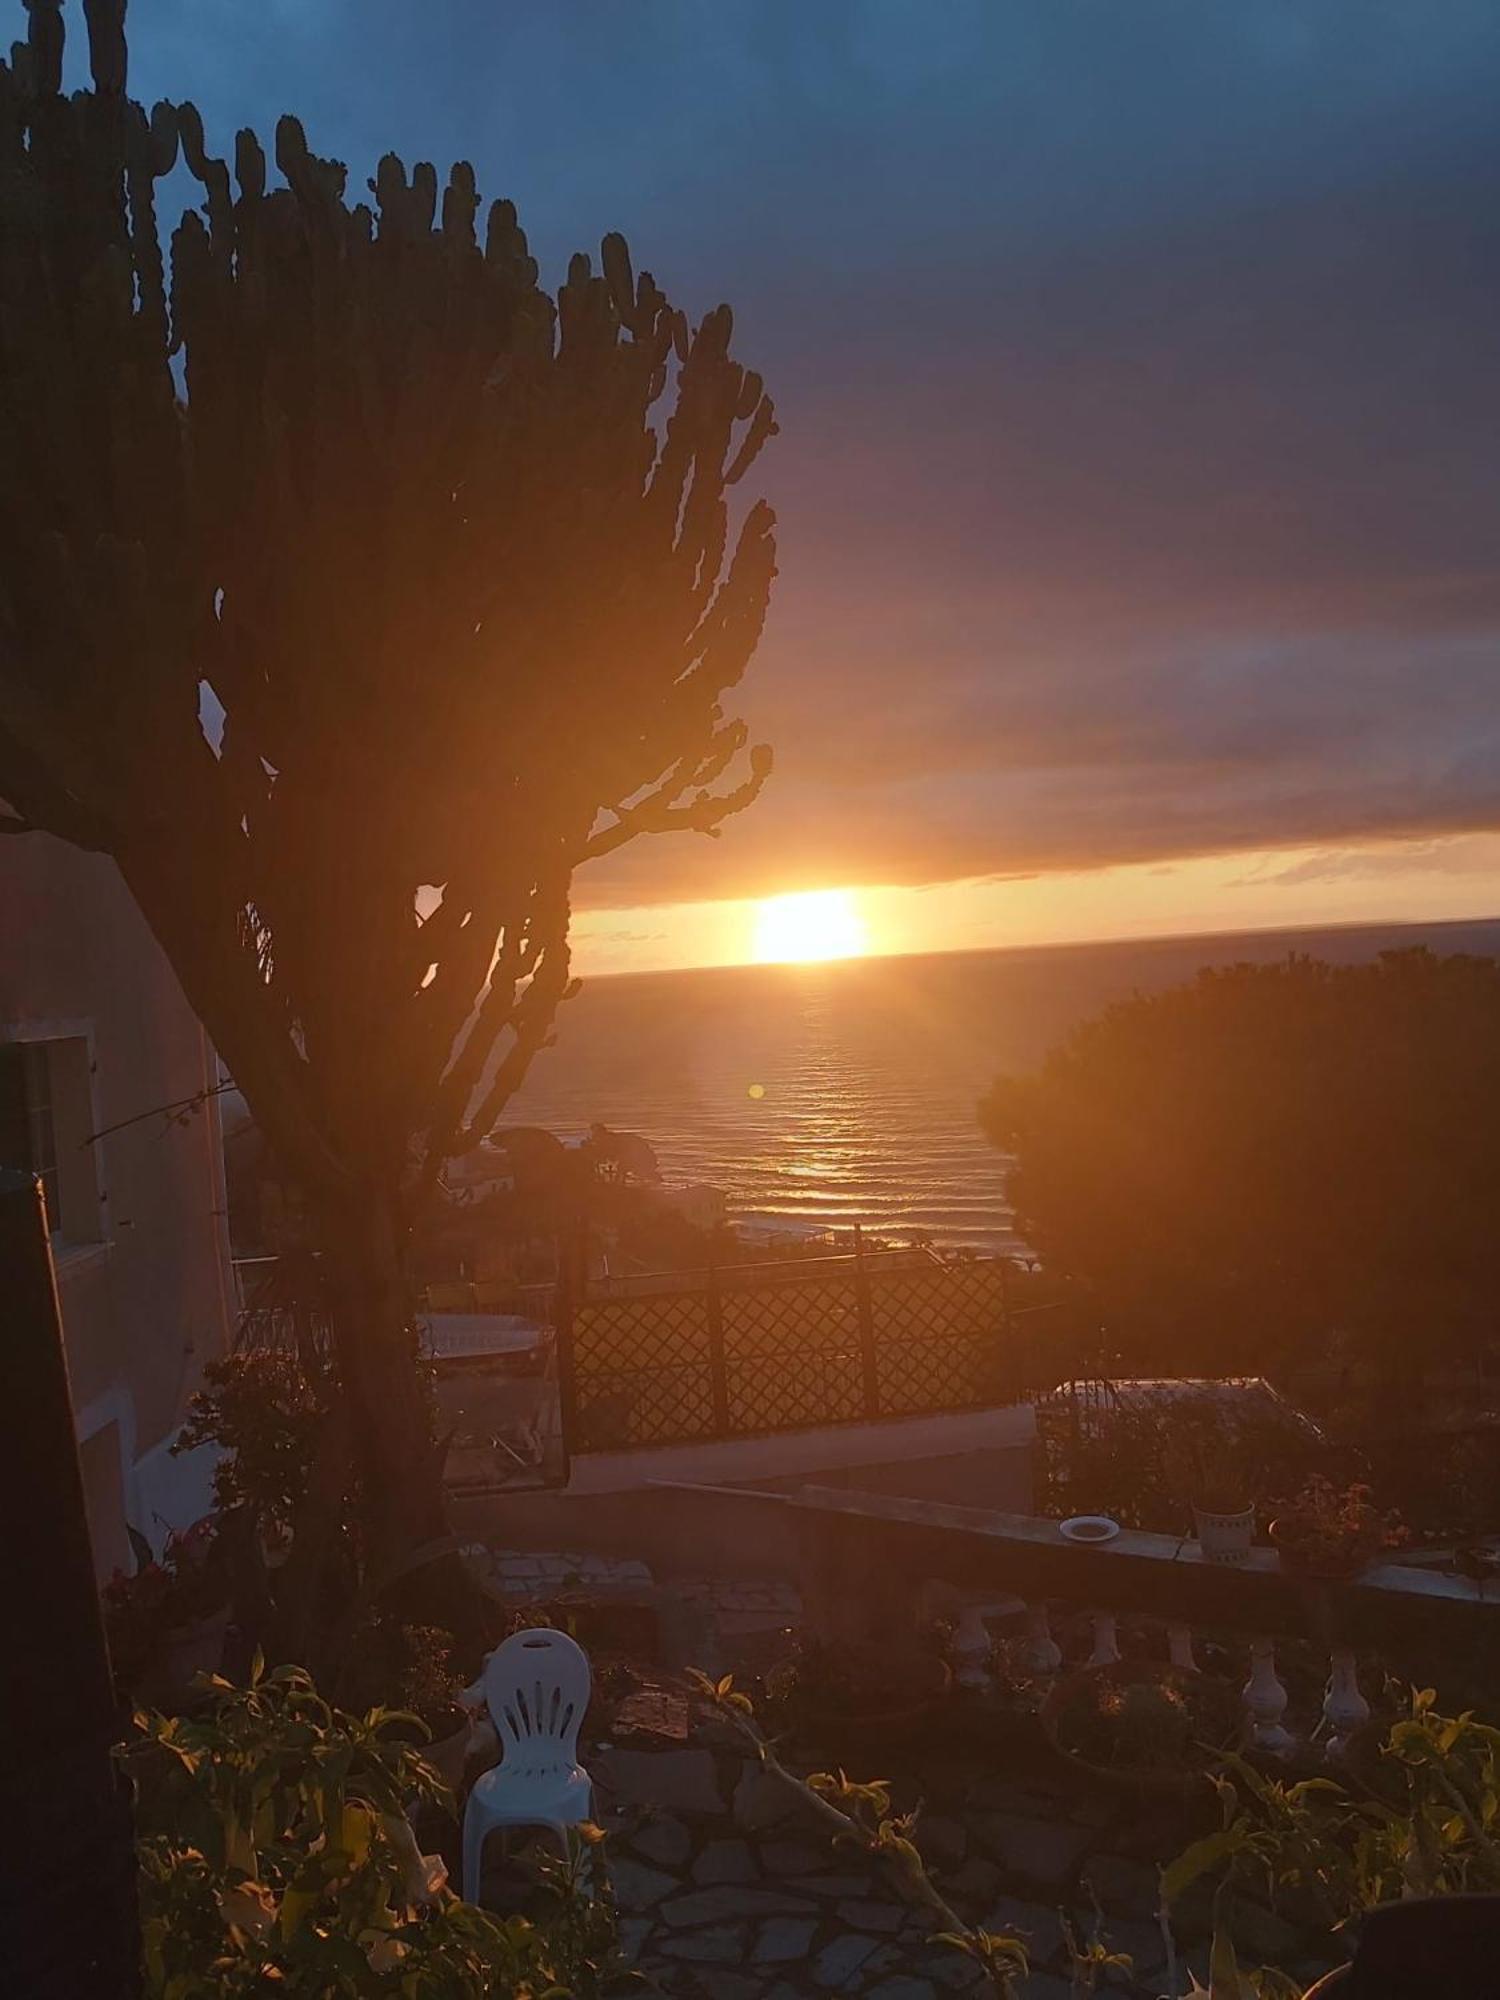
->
[0, 0, 776, 1592]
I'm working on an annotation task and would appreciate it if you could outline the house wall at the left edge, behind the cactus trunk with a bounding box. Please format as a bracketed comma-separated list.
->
[0, 834, 232, 1578]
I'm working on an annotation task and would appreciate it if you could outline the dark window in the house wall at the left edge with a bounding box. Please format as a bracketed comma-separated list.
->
[0, 1036, 100, 1242]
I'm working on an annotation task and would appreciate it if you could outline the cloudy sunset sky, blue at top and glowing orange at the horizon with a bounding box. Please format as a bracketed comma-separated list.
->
[126, 0, 1500, 970]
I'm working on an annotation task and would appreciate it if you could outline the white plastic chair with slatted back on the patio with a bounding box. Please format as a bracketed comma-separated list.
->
[464, 1626, 594, 1902]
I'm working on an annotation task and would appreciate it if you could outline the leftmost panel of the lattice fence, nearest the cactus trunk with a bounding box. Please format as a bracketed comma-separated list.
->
[572, 1292, 716, 1452]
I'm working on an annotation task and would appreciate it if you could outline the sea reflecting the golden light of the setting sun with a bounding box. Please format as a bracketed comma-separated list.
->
[502, 920, 1500, 1250]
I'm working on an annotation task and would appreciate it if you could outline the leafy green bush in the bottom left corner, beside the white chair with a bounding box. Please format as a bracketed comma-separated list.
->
[122, 1662, 612, 2000]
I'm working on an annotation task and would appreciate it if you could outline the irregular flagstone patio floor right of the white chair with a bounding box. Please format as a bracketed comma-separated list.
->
[592, 1688, 1240, 2000]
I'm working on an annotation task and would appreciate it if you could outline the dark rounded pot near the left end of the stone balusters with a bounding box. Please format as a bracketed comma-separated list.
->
[766, 1642, 952, 1756]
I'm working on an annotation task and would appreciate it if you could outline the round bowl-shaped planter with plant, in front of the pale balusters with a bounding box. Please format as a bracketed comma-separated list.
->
[1040, 1660, 1244, 1796]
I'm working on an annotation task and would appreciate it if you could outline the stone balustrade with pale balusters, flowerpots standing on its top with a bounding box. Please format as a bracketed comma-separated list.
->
[688, 1486, 1500, 1756]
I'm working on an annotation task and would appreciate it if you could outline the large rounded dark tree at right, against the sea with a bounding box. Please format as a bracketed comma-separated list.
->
[982, 950, 1500, 1372]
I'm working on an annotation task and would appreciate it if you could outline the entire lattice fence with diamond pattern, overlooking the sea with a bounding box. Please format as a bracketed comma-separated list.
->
[558, 1256, 1066, 1452]
